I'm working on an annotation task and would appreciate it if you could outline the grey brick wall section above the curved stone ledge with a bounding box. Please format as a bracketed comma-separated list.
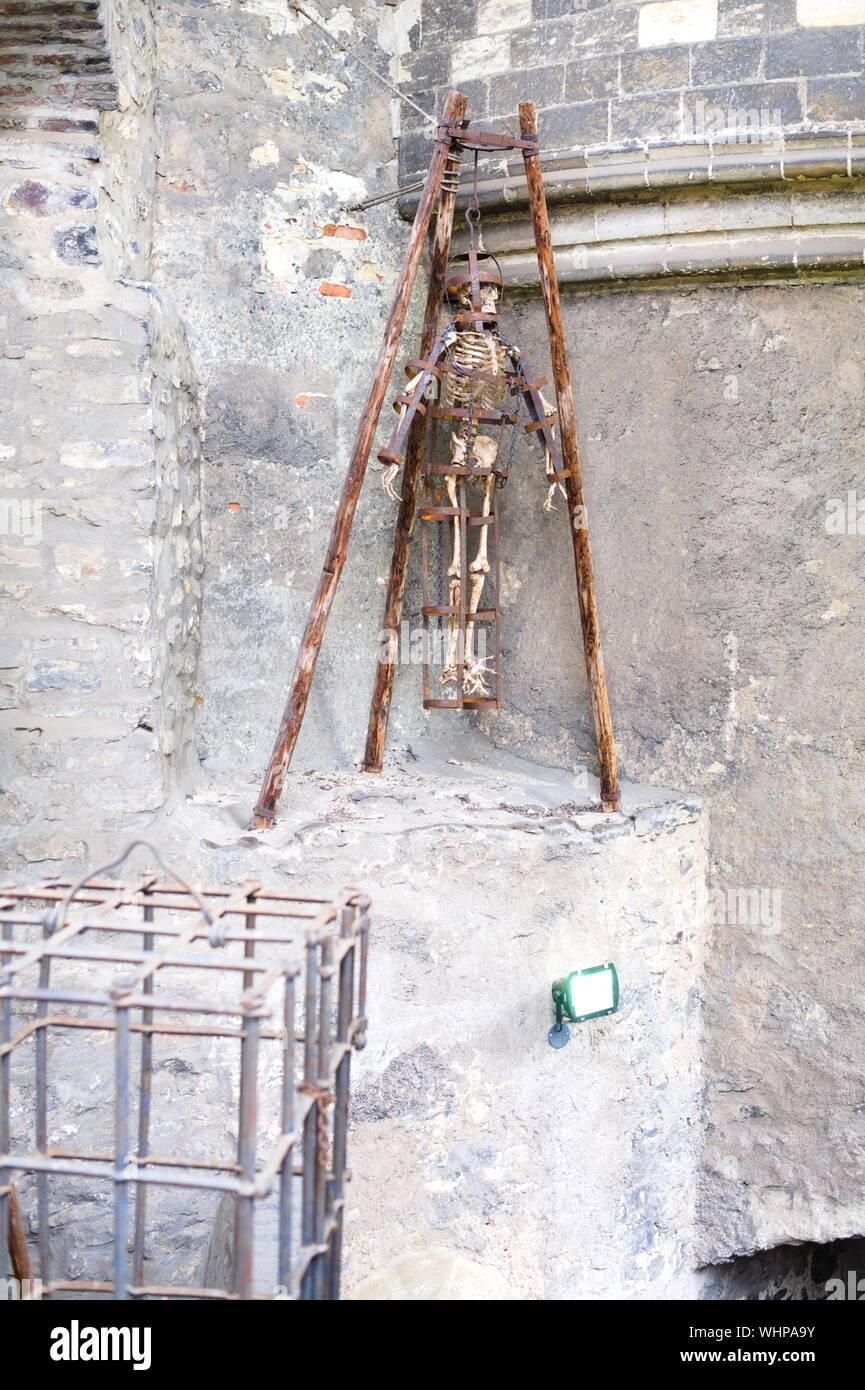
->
[401, 0, 865, 172]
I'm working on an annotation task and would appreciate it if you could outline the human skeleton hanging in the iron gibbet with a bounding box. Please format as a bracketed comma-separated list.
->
[378, 247, 565, 696]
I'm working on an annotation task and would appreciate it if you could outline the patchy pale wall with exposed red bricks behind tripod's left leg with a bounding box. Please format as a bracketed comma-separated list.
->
[154, 0, 421, 781]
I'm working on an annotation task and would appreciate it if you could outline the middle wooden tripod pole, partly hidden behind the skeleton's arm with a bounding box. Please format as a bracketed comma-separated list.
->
[362, 96, 466, 773]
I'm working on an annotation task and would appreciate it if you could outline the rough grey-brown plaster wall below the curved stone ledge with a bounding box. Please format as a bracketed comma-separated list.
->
[495, 285, 865, 1258]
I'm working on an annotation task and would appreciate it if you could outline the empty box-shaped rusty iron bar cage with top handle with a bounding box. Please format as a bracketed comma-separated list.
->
[0, 847, 369, 1300]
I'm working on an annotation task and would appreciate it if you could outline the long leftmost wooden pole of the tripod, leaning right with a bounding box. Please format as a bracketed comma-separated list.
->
[253, 92, 466, 830]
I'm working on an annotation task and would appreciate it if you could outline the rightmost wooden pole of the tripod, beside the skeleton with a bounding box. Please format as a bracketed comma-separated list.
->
[520, 101, 619, 810]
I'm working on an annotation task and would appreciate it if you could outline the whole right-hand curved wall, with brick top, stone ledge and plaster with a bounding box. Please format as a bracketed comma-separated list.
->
[394, 0, 865, 1261]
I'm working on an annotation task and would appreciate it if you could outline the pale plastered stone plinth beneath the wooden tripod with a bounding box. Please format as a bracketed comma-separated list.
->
[166, 752, 706, 1300]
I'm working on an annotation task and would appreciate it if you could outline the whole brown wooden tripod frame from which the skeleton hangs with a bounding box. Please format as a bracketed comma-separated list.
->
[253, 92, 619, 828]
